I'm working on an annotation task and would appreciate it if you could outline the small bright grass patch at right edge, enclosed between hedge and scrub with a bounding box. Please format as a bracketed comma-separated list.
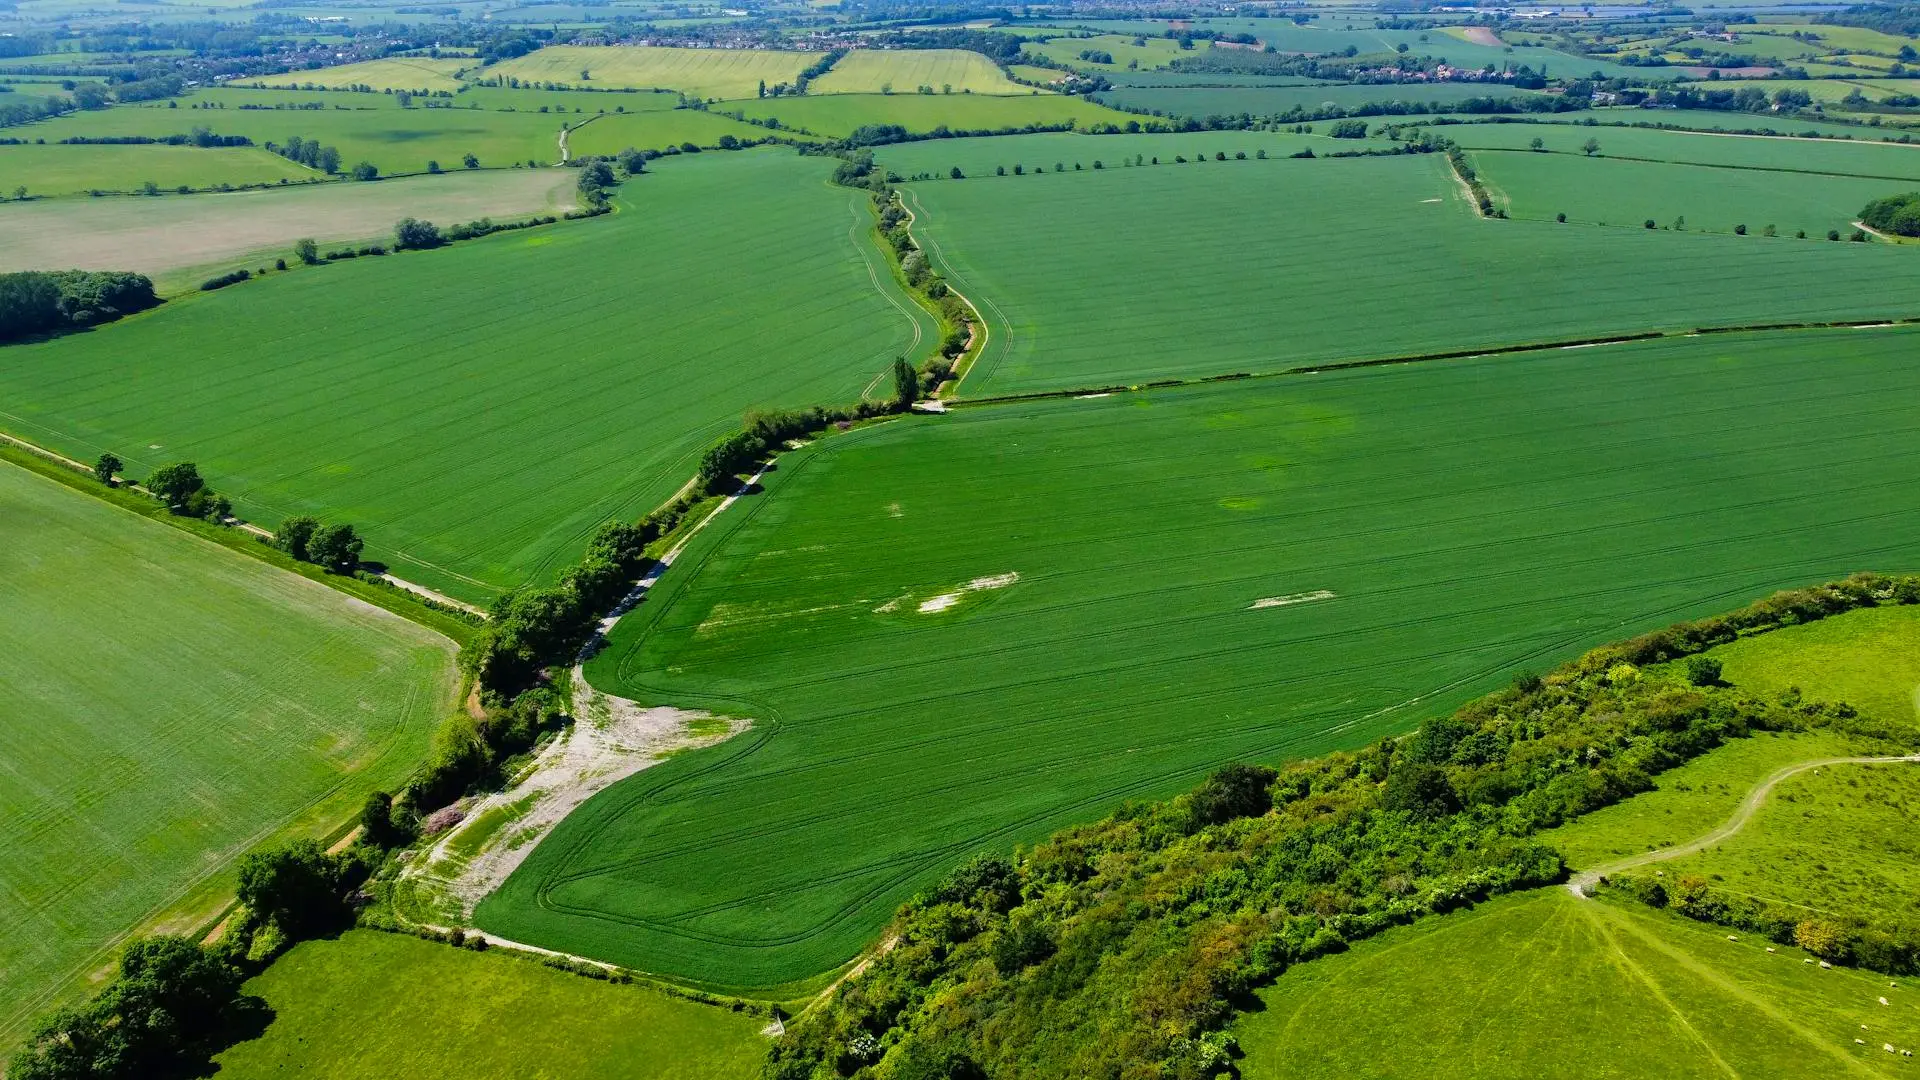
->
[1713, 607, 1920, 724]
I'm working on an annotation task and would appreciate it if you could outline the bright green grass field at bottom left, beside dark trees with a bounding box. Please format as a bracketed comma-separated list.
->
[206, 930, 766, 1080]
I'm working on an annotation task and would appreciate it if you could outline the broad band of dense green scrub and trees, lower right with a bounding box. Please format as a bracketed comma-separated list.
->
[766, 577, 1920, 1080]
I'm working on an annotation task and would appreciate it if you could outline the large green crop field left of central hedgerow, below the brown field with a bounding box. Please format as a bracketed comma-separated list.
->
[0, 148, 933, 600]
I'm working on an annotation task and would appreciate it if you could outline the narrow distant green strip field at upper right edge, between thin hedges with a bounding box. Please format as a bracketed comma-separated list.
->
[1446, 117, 1920, 183]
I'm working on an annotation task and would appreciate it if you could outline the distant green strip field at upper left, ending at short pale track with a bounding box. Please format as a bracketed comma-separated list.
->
[16, 104, 572, 175]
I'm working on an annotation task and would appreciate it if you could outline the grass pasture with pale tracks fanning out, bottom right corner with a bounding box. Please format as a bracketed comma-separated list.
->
[1236, 890, 1920, 1080]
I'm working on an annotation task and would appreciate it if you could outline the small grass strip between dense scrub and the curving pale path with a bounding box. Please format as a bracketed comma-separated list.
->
[1540, 732, 1862, 871]
